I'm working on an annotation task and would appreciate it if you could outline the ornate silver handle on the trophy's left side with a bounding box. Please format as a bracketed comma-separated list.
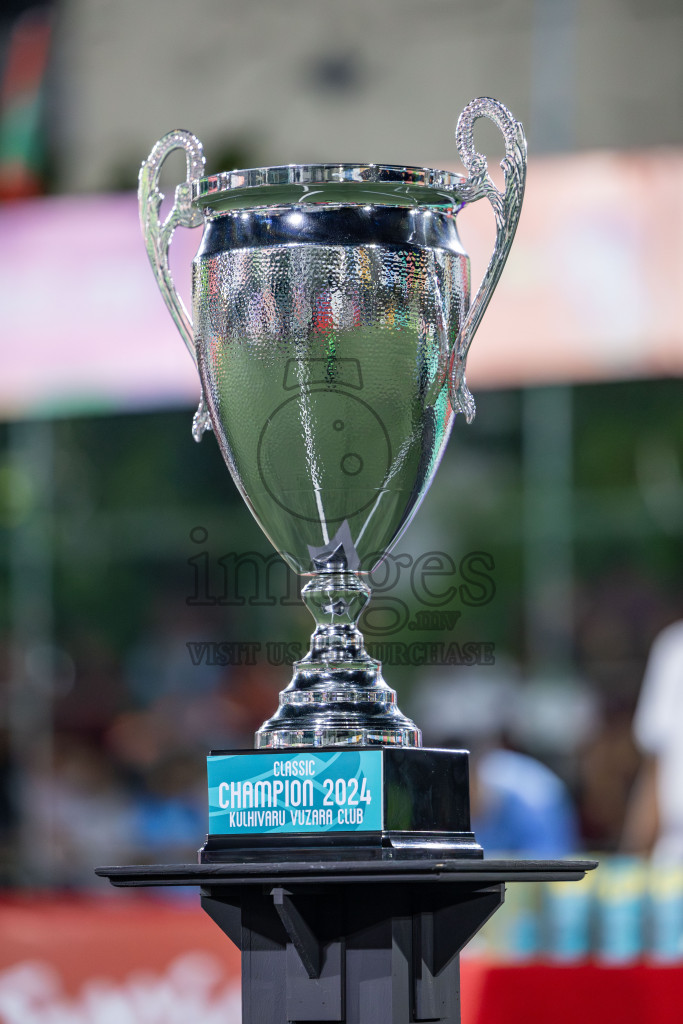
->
[137, 130, 211, 441]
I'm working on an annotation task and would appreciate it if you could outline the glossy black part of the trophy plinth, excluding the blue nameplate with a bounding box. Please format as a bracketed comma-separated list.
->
[199, 746, 483, 864]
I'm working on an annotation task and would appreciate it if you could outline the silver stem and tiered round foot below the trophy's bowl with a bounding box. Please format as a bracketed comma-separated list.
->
[256, 570, 421, 749]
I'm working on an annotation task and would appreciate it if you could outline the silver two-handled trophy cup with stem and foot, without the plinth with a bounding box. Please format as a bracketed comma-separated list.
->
[139, 98, 526, 749]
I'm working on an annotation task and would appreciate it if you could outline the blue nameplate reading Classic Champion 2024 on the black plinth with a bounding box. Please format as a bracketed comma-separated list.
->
[207, 750, 384, 836]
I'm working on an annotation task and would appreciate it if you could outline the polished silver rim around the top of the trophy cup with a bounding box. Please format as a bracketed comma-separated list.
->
[191, 164, 465, 205]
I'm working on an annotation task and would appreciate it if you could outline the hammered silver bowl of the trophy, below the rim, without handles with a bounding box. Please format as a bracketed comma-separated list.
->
[194, 207, 469, 573]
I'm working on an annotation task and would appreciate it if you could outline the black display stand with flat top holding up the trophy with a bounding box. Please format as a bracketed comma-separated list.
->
[97, 856, 596, 1024]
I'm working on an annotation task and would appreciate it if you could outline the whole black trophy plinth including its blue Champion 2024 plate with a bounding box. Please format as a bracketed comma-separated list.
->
[200, 746, 483, 864]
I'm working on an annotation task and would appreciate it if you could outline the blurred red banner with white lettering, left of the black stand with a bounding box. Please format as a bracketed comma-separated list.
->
[0, 893, 242, 1024]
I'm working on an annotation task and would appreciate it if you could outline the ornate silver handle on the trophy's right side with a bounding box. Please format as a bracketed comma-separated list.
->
[449, 96, 526, 423]
